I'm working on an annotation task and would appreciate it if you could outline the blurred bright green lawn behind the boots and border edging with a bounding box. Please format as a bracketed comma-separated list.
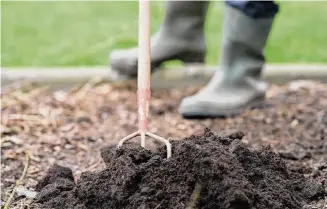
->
[1, 1, 327, 67]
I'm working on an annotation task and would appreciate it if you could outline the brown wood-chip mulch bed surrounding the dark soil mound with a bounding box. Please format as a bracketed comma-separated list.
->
[1, 81, 327, 208]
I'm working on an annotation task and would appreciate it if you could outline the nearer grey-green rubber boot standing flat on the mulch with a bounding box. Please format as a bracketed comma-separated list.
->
[179, 5, 274, 118]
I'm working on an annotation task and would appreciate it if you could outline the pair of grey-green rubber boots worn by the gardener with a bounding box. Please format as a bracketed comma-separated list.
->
[109, 1, 274, 117]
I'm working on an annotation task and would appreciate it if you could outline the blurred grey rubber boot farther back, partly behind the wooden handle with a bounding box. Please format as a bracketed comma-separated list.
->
[109, 1, 209, 77]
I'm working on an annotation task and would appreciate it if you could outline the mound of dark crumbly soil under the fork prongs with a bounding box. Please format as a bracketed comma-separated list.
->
[36, 129, 324, 209]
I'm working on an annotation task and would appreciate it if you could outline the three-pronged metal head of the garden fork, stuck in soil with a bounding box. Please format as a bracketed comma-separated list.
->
[117, 131, 171, 158]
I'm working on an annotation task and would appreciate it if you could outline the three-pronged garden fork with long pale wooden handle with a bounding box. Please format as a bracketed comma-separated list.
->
[117, 0, 171, 158]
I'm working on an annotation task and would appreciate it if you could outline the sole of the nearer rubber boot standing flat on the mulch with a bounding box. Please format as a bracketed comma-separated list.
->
[180, 97, 264, 119]
